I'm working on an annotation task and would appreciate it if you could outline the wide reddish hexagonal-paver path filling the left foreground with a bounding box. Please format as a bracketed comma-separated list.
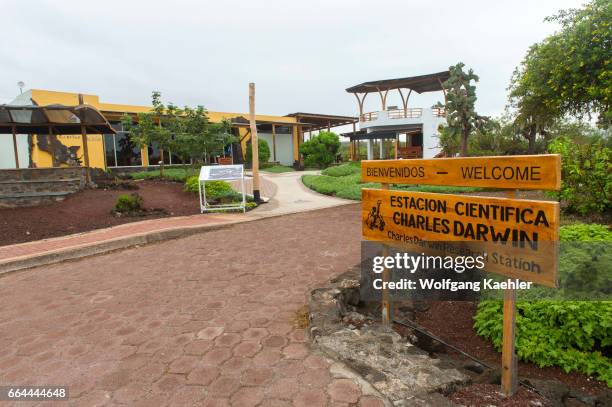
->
[0, 205, 382, 406]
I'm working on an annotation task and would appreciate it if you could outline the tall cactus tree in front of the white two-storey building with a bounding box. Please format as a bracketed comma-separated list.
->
[437, 62, 487, 157]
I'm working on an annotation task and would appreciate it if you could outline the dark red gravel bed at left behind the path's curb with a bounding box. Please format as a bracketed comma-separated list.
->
[0, 181, 199, 246]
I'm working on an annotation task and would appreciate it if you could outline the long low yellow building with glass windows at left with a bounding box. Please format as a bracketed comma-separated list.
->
[0, 89, 356, 169]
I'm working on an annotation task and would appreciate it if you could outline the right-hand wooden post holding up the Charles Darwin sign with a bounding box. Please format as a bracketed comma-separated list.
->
[501, 190, 518, 397]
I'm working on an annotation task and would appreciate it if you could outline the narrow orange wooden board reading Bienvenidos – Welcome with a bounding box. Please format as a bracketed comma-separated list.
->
[361, 154, 561, 190]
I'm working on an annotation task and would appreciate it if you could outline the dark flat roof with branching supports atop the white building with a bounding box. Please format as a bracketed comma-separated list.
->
[346, 71, 450, 117]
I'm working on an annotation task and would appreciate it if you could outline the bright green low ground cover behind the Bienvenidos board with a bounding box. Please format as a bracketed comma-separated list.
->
[302, 163, 485, 201]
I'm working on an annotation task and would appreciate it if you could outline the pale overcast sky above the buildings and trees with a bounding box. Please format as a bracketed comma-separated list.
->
[0, 0, 582, 119]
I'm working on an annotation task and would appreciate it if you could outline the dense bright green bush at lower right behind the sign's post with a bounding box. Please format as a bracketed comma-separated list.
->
[474, 224, 612, 387]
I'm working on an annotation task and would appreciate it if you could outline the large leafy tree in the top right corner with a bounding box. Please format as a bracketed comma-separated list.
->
[511, 0, 612, 127]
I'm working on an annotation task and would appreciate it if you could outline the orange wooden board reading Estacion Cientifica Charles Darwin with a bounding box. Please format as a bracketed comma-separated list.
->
[361, 189, 559, 287]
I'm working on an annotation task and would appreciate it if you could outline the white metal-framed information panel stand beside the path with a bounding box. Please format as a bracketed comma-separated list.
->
[198, 164, 246, 213]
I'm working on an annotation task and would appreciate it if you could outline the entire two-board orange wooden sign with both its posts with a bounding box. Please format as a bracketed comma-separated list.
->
[361, 154, 561, 396]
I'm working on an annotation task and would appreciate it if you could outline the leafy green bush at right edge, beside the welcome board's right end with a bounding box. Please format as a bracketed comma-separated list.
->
[549, 137, 612, 215]
